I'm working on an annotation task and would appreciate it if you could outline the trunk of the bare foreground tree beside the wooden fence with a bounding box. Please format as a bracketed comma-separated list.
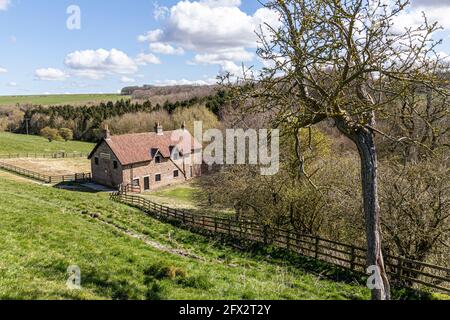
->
[338, 121, 390, 300]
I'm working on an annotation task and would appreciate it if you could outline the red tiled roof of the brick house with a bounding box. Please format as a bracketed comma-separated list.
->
[90, 130, 202, 165]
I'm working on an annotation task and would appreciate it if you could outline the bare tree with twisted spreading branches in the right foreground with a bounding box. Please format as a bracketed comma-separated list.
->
[228, 0, 446, 300]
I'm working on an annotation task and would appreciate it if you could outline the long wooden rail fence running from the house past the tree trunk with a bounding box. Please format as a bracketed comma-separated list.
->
[111, 192, 450, 294]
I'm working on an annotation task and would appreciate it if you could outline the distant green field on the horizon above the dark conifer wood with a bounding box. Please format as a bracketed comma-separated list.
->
[0, 94, 128, 106]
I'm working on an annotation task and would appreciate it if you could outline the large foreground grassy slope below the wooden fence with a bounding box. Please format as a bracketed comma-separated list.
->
[0, 177, 369, 299]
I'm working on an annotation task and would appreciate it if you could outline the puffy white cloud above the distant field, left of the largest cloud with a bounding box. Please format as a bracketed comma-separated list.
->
[64, 49, 138, 80]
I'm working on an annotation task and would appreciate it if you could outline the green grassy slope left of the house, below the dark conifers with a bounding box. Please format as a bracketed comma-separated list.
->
[0, 132, 94, 154]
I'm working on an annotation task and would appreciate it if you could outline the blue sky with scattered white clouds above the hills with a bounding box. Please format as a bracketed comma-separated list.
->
[0, 0, 450, 95]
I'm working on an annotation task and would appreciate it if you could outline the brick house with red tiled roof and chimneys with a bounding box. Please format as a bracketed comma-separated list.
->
[89, 124, 202, 191]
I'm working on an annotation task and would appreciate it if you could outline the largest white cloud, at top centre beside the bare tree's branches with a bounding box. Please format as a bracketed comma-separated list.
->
[139, 0, 280, 75]
